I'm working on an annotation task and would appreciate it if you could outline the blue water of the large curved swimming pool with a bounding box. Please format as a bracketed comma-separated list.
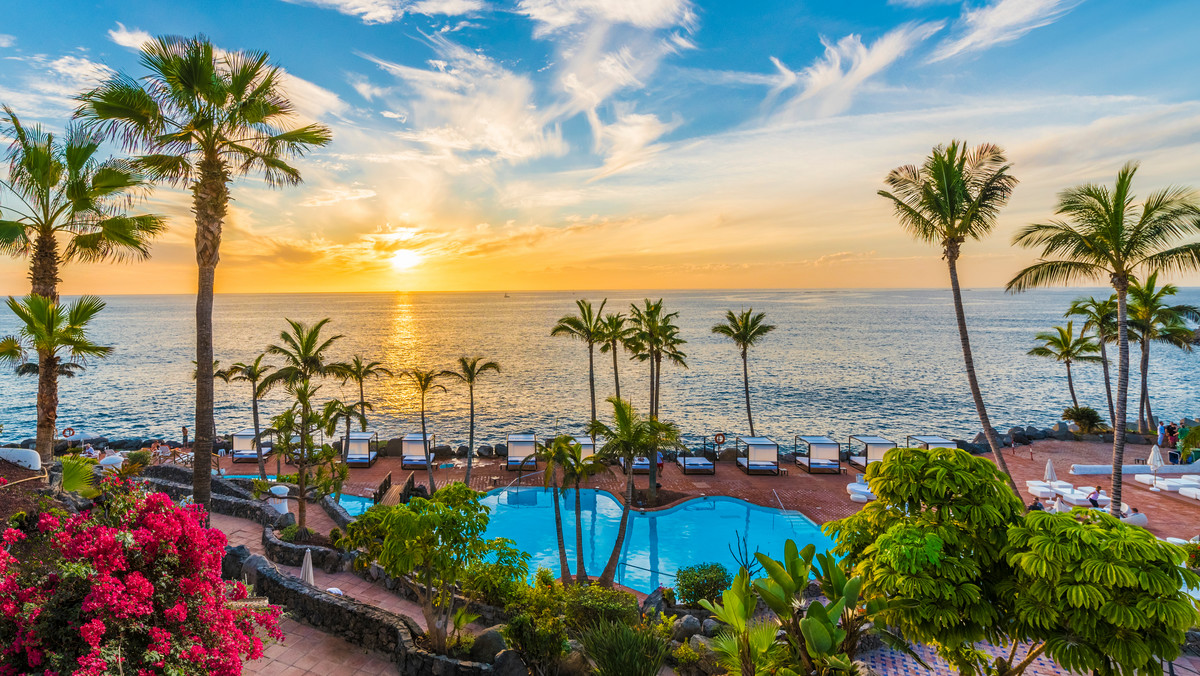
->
[482, 486, 834, 592]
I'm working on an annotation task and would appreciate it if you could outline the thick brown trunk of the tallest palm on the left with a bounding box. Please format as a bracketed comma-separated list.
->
[192, 155, 228, 514]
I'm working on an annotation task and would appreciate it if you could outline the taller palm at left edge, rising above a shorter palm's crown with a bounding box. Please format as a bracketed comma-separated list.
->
[0, 111, 166, 468]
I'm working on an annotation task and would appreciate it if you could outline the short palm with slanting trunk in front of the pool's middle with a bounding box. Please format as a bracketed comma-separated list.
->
[588, 396, 679, 587]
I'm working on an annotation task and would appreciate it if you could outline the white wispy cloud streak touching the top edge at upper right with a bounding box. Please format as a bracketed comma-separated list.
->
[930, 0, 1082, 62]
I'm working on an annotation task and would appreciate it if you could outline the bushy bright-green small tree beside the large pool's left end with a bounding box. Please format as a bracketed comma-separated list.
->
[379, 483, 512, 654]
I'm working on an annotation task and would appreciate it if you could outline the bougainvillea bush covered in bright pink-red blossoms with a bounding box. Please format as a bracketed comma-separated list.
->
[0, 478, 282, 676]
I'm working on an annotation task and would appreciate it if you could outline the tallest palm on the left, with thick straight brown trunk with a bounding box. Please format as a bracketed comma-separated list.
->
[76, 36, 330, 505]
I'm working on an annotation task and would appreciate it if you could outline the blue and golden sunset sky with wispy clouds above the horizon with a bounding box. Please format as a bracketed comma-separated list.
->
[0, 0, 1200, 294]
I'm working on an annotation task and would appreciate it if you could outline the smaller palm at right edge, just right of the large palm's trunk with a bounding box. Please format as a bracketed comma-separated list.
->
[1129, 271, 1200, 433]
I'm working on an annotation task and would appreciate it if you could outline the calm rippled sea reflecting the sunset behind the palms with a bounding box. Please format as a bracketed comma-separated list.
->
[0, 288, 1200, 447]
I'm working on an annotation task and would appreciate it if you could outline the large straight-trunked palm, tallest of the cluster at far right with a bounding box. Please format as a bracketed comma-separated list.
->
[1006, 162, 1200, 516]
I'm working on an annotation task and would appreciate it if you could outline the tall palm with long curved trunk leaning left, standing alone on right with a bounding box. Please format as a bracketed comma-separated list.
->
[878, 140, 1018, 492]
